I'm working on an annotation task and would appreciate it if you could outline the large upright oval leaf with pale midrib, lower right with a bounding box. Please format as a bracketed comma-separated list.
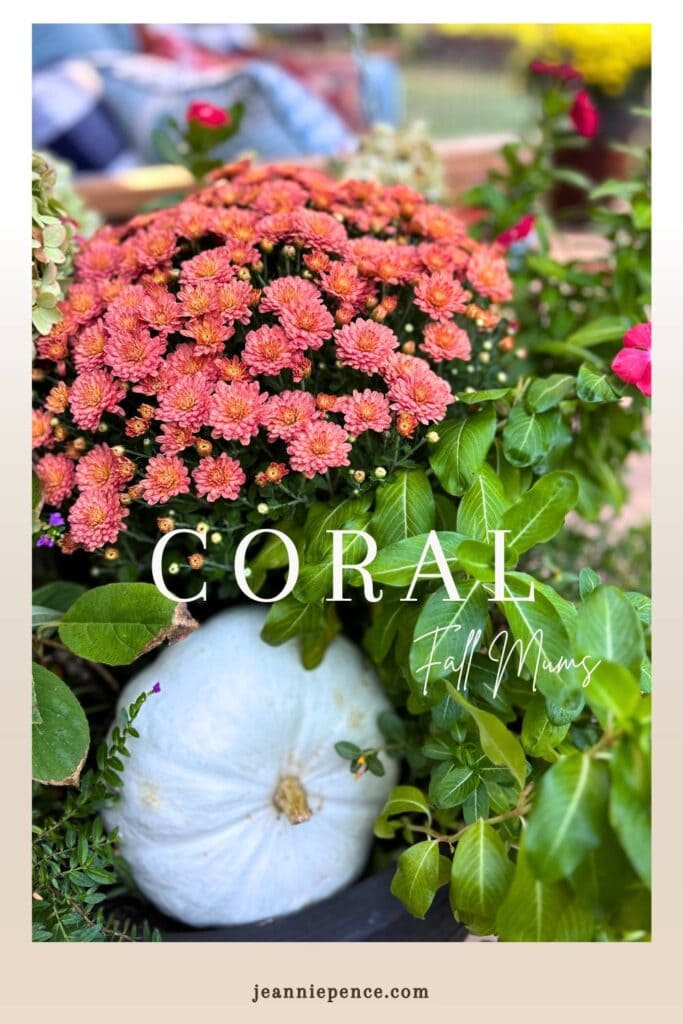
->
[525, 753, 609, 882]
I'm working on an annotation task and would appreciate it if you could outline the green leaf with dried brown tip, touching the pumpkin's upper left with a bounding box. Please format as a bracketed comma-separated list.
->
[59, 583, 197, 665]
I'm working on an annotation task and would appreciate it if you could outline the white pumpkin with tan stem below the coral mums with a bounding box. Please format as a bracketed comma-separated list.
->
[104, 606, 397, 927]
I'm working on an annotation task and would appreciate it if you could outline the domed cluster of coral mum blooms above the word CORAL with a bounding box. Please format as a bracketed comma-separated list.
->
[33, 158, 511, 551]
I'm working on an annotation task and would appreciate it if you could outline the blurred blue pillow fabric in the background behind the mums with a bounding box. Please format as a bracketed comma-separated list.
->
[33, 25, 400, 170]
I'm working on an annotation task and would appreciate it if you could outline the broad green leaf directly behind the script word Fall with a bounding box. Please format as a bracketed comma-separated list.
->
[410, 581, 488, 694]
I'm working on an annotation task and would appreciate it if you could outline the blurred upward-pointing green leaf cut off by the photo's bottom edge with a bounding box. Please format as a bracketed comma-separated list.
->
[496, 846, 570, 942]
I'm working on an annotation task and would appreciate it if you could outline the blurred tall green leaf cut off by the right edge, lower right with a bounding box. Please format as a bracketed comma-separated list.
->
[609, 737, 652, 887]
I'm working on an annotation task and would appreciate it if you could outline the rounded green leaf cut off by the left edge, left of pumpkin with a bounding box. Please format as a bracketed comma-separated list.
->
[32, 663, 90, 785]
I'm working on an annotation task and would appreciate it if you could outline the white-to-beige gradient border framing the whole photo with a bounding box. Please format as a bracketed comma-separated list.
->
[6, 0, 683, 1024]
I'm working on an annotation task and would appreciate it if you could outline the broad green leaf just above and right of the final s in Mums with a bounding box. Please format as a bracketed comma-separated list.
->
[574, 585, 645, 675]
